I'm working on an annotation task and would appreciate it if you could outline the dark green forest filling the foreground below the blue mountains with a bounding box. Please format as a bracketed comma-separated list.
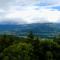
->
[0, 32, 60, 60]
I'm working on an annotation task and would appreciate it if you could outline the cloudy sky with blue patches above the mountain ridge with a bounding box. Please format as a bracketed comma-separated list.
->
[0, 0, 60, 24]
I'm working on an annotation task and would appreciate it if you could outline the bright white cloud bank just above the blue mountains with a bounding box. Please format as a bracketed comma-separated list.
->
[0, 7, 60, 24]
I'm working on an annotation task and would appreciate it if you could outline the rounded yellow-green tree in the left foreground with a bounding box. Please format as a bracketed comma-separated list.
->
[2, 43, 32, 60]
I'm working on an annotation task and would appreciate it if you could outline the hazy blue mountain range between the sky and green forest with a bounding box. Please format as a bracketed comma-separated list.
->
[0, 23, 60, 37]
